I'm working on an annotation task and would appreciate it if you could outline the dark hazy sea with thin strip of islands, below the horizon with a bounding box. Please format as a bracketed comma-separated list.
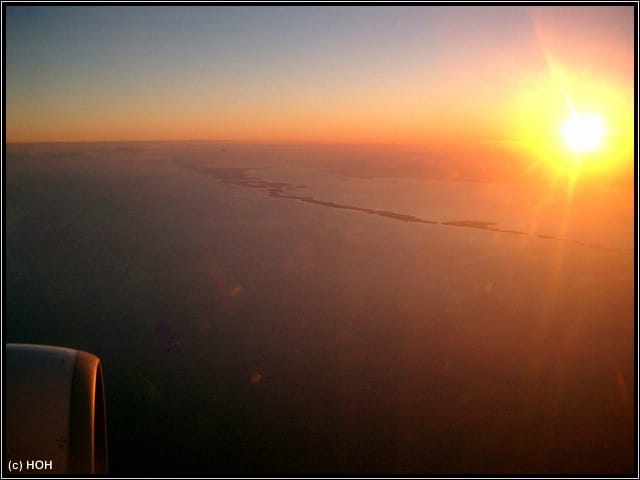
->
[4, 143, 636, 476]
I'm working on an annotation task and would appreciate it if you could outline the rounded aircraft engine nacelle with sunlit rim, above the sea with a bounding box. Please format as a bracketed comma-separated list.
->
[4, 343, 107, 474]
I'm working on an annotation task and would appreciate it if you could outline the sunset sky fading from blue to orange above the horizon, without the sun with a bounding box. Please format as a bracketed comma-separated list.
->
[5, 5, 635, 163]
